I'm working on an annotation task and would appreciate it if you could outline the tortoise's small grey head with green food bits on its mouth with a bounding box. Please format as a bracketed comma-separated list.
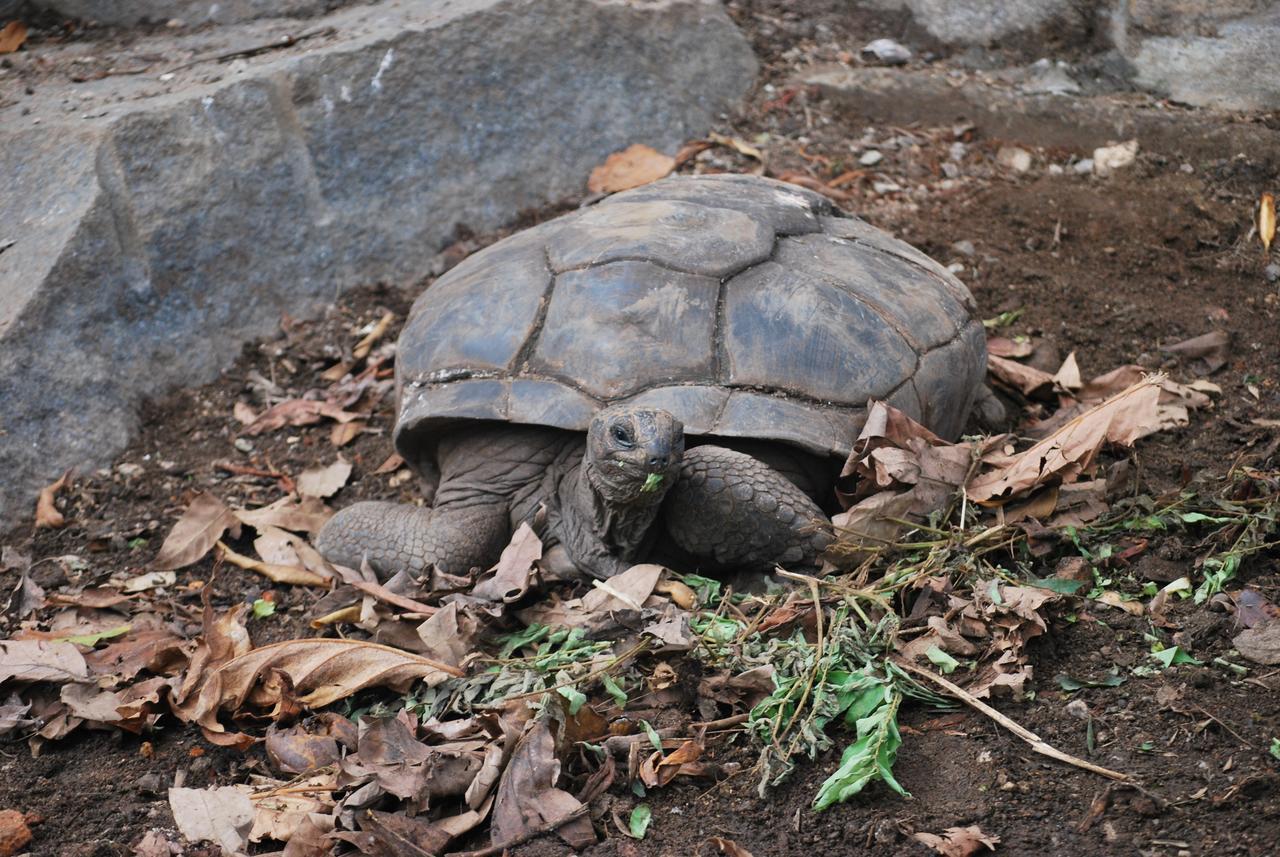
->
[582, 405, 685, 505]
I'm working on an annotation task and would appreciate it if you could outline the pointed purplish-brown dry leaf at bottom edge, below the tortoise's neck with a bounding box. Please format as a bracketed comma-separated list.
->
[490, 720, 595, 849]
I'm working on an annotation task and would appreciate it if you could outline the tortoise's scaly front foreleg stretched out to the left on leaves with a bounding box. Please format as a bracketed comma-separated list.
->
[316, 501, 511, 578]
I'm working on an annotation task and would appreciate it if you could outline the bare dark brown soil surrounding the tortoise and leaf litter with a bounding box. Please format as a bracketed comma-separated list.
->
[0, 1, 1280, 857]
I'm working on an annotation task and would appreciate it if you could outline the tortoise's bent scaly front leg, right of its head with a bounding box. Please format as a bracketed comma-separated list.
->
[663, 446, 832, 572]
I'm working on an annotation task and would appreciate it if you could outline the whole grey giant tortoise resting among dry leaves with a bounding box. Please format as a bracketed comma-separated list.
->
[317, 175, 986, 578]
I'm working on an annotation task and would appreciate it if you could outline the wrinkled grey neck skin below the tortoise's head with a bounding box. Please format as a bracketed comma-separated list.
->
[557, 453, 672, 578]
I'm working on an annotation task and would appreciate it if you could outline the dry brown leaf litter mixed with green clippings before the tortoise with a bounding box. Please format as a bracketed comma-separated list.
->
[0, 318, 1280, 854]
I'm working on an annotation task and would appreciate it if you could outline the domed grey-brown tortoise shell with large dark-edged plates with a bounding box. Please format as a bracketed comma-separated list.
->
[396, 175, 987, 460]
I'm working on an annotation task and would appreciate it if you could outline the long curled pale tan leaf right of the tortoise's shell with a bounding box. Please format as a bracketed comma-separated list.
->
[965, 377, 1161, 505]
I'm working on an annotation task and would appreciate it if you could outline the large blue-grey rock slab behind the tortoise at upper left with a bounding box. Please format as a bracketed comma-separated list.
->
[0, 0, 755, 522]
